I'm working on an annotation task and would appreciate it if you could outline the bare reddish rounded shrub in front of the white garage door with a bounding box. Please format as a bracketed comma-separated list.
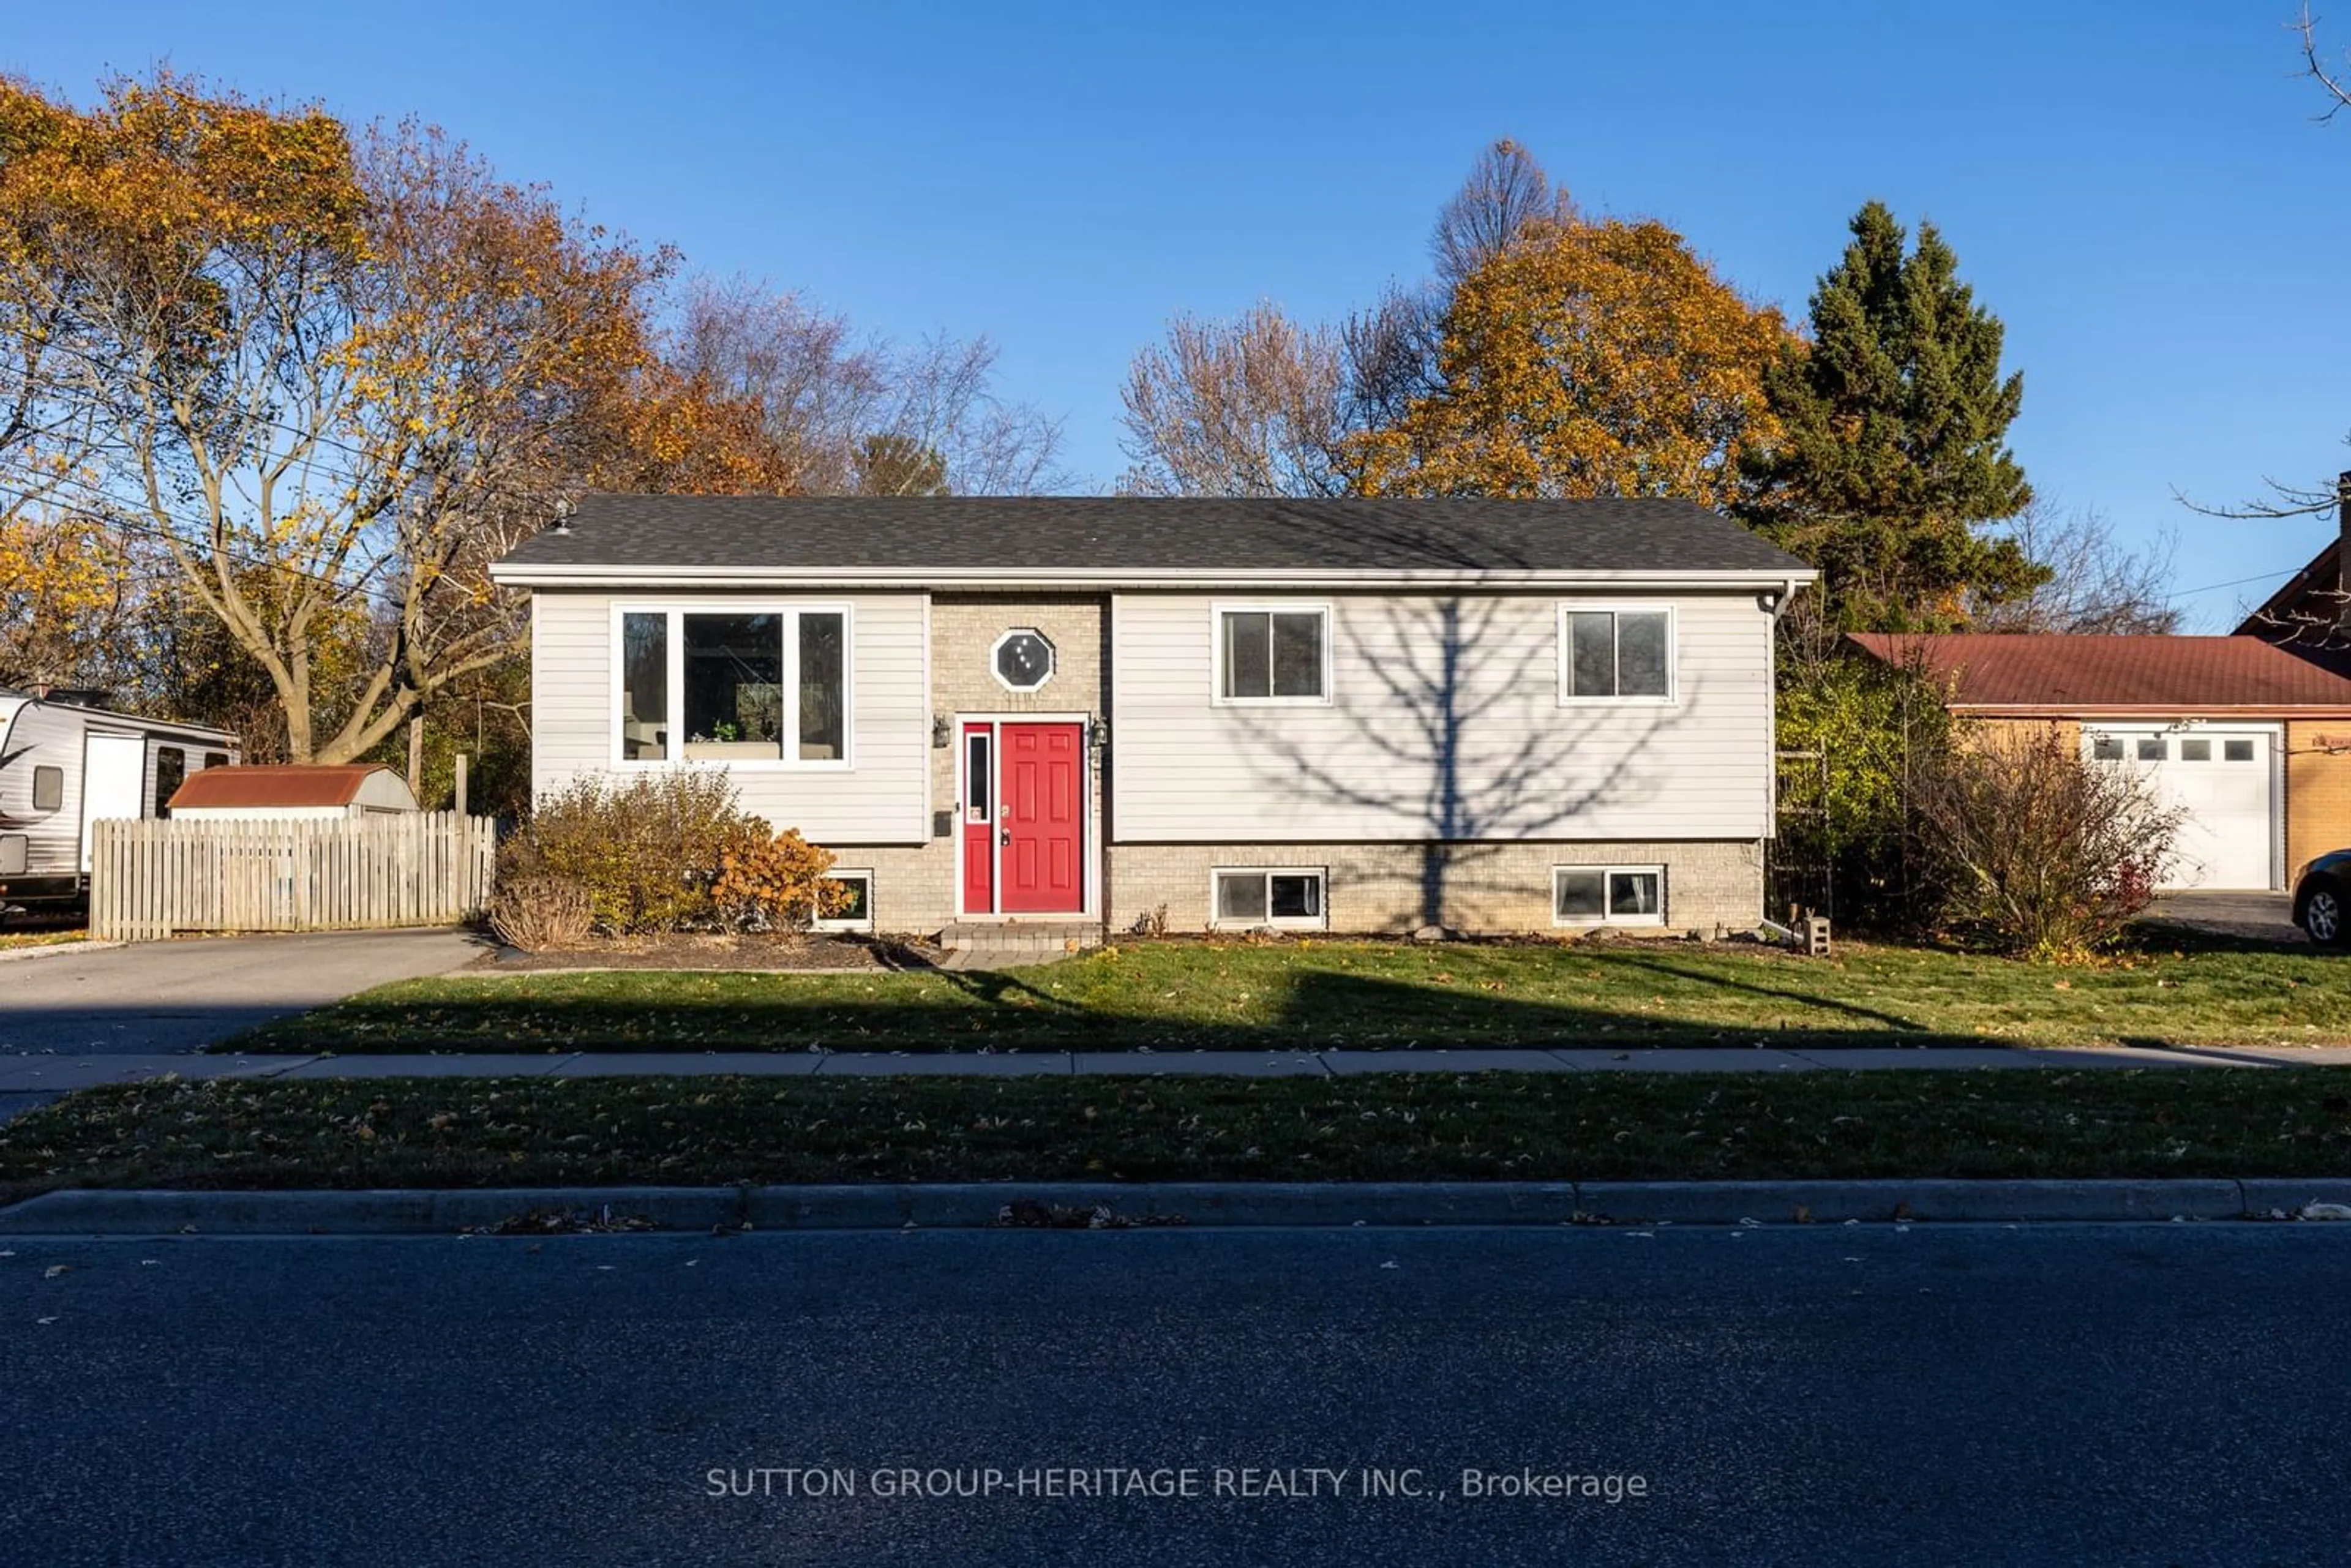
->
[1916, 726, 2182, 961]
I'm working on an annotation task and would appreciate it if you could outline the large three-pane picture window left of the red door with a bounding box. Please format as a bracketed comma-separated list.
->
[613, 607, 849, 767]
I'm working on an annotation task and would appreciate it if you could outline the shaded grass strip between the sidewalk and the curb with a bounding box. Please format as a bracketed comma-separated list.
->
[0, 1067, 2351, 1196]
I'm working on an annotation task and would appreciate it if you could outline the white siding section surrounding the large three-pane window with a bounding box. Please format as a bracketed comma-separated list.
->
[531, 588, 931, 849]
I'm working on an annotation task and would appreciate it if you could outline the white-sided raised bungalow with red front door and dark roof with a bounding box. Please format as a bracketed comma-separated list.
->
[493, 496, 1813, 933]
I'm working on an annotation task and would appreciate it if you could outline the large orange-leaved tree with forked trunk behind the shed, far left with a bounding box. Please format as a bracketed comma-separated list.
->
[0, 75, 668, 762]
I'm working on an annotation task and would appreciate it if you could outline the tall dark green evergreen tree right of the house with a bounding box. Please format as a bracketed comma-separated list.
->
[1749, 202, 2048, 630]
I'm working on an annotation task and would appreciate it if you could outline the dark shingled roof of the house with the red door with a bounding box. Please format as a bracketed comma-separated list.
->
[501, 496, 1810, 576]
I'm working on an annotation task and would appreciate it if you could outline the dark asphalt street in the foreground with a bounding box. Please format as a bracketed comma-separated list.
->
[0, 1223, 2351, 1566]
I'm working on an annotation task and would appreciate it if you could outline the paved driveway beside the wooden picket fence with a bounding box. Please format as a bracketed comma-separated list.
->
[0, 931, 487, 1056]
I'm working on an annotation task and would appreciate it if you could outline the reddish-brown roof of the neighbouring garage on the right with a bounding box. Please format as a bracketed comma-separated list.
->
[1850, 632, 2351, 715]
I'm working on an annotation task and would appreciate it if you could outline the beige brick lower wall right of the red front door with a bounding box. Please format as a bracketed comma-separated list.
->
[1108, 842, 1763, 936]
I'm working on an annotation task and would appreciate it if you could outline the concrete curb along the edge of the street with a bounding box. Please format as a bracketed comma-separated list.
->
[0, 1178, 2351, 1237]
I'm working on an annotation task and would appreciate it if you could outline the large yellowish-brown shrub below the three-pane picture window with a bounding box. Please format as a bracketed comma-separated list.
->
[498, 769, 771, 933]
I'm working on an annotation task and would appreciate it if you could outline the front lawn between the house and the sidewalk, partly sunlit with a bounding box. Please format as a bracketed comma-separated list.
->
[230, 943, 2351, 1051]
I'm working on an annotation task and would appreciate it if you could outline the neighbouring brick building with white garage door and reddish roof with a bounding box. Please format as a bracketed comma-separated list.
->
[1853, 632, 2351, 888]
